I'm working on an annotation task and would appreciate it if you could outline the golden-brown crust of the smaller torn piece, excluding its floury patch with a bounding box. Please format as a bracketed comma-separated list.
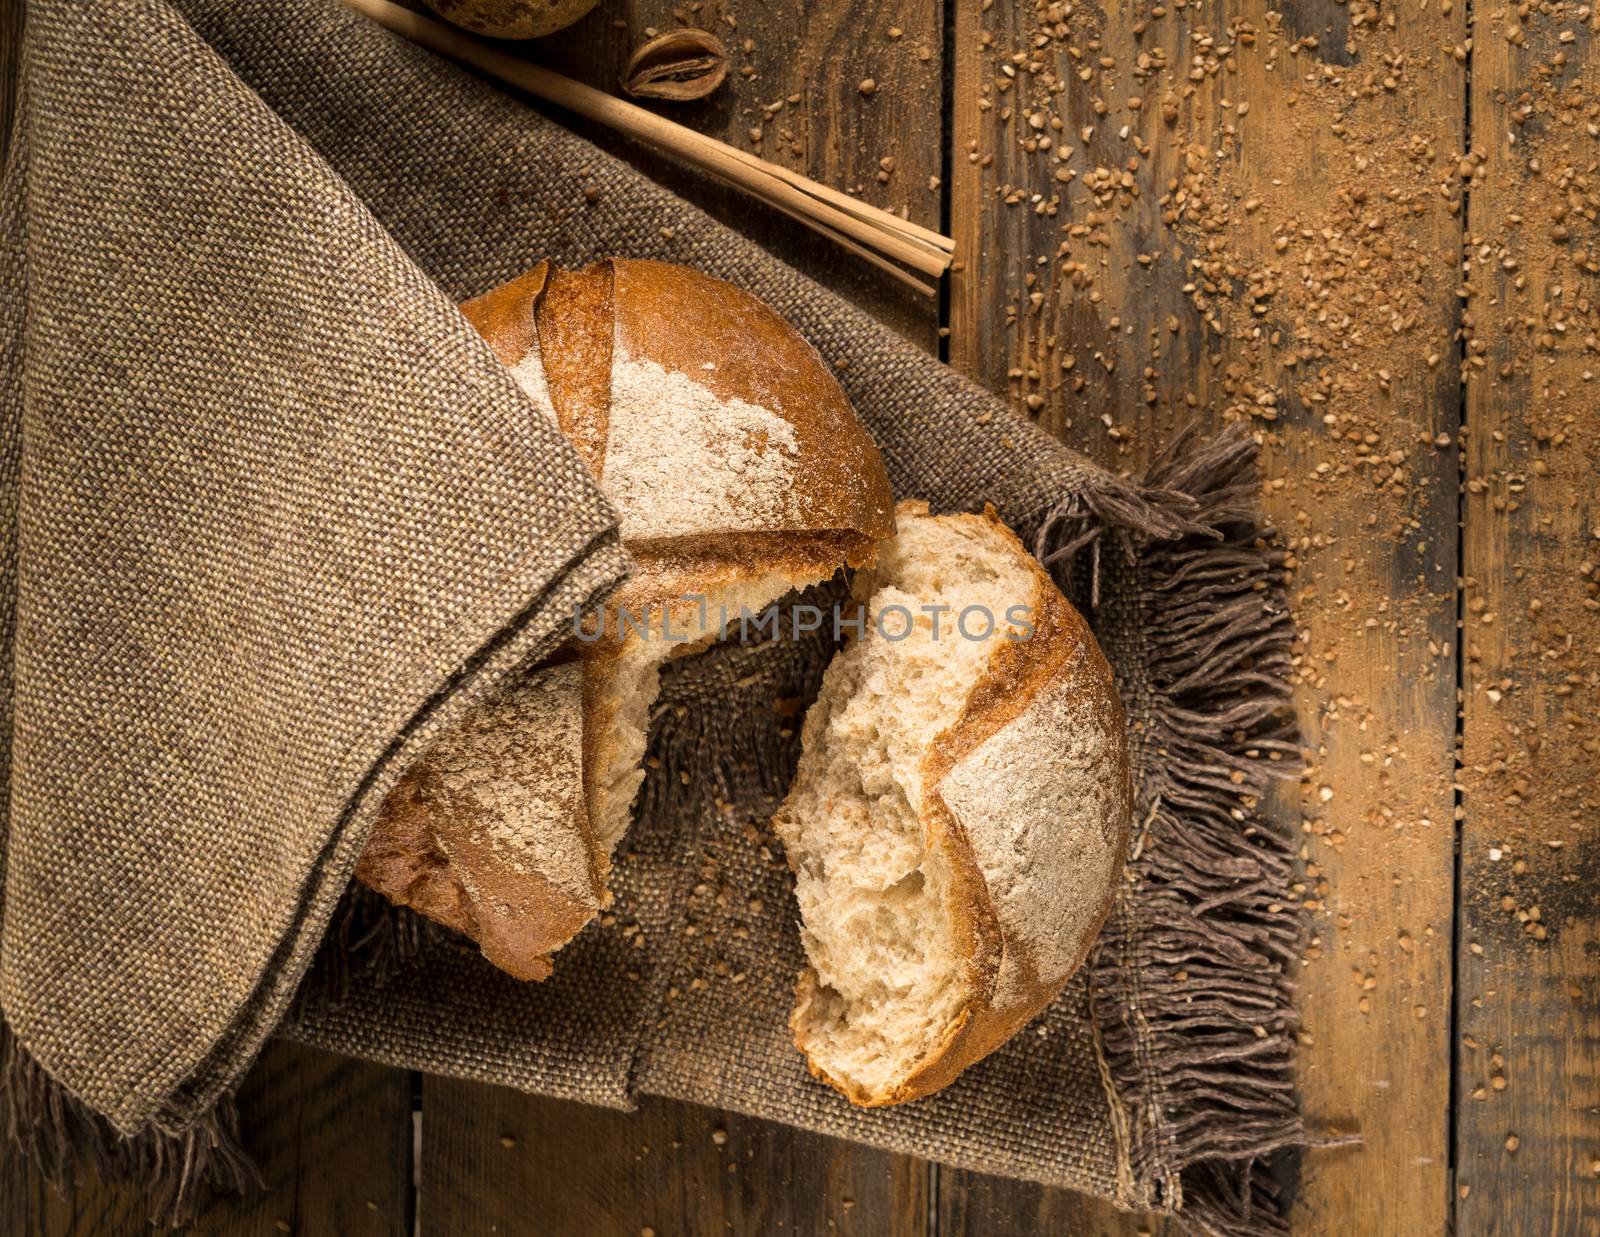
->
[790, 502, 1133, 1107]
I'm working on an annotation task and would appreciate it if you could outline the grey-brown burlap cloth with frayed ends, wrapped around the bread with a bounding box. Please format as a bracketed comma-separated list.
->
[0, 0, 1302, 1232]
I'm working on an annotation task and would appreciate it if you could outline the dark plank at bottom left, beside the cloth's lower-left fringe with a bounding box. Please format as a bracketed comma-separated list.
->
[0, 1043, 411, 1237]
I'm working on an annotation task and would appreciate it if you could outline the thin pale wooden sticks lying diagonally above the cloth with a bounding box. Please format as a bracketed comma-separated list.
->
[344, 0, 955, 294]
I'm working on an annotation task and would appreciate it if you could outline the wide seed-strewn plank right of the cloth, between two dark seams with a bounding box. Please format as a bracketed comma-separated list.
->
[941, 0, 1464, 1232]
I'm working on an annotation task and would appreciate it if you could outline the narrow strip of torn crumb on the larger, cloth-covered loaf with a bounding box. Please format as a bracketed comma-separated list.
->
[589, 568, 832, 853]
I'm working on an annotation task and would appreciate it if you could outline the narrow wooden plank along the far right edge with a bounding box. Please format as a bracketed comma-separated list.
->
[1456, 3, 1600, 1235]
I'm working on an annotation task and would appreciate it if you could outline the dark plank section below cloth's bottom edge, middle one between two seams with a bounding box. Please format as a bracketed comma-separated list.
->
[419, 1079, 928, 1237]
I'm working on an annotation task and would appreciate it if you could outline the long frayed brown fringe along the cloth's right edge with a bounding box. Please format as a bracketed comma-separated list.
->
[1035, 426, 1312, 1237]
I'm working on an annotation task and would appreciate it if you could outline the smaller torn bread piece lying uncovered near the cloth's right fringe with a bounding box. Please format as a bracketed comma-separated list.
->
[774, 504, 1131, 1106]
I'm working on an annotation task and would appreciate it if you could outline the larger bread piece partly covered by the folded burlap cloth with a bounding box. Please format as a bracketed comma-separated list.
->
[357, 259, 894, 978]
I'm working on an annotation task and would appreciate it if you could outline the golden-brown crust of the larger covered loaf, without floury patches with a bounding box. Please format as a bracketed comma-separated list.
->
[357, 259, 893, 978]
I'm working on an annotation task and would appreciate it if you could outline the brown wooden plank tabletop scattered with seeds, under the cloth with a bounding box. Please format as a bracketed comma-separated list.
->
[0, 0, 1600, 1237]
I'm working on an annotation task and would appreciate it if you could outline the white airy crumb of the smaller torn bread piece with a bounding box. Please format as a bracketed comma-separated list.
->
[774, 509, 1034, 1103]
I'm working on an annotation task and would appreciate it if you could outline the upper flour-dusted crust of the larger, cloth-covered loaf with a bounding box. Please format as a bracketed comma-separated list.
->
[461, 258, 894, 557]
